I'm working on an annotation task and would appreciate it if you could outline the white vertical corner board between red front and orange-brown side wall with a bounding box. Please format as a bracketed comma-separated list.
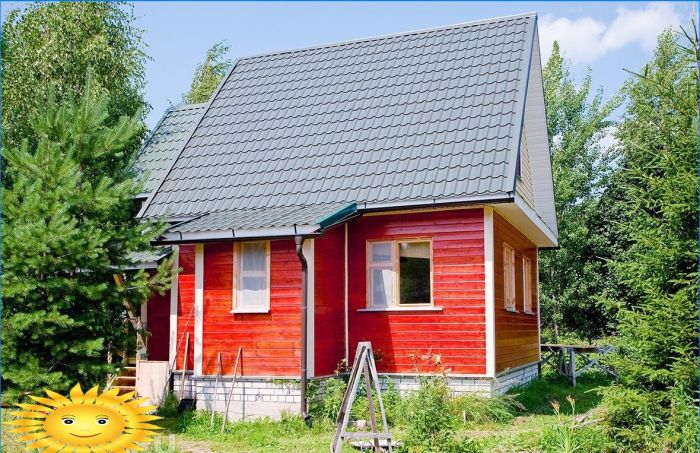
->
[484, 206, 496, 377]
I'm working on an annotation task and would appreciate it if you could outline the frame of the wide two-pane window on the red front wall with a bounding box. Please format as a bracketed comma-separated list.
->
[365, 238, 435, 310]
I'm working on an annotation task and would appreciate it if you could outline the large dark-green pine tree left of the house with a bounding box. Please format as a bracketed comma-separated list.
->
[2, 77, 169, 399]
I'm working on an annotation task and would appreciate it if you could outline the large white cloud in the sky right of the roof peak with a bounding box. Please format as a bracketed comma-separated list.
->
[539, 3, 681, 64]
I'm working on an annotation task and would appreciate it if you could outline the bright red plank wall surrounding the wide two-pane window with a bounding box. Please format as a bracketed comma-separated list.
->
[346, 209, 486, 374]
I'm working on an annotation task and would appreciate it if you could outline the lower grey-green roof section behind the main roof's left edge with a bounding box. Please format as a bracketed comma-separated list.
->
[135, 104, 207, 193]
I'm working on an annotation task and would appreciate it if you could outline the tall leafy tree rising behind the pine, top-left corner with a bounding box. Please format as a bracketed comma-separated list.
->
[2, 2, 147, 152]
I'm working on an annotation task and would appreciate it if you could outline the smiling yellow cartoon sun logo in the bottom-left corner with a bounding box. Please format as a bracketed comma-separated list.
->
[7, 384, 162, 453]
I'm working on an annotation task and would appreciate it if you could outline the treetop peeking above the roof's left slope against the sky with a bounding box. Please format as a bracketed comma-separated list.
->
[183, 42, 233, 104]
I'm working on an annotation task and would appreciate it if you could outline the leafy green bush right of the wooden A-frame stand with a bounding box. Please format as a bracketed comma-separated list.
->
[402, 376, 476, 453]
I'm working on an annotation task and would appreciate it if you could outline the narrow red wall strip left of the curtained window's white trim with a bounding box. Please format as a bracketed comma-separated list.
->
[175, 245, 194, 370]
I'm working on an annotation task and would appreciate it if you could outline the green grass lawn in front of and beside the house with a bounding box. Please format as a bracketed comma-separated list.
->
[2, 373, 609, 453]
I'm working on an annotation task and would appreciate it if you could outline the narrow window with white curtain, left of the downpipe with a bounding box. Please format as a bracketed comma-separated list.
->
[233, 242, 270, 313]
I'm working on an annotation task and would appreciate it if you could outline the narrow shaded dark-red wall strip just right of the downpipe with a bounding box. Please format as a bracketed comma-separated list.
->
[314, 225, 345, 376]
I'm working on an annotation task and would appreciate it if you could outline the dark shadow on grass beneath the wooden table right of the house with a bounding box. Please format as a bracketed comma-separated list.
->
[508, 372, 612, 415]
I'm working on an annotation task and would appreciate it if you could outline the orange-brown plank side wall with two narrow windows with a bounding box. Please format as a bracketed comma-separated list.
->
[493, 212, 540, 372]
